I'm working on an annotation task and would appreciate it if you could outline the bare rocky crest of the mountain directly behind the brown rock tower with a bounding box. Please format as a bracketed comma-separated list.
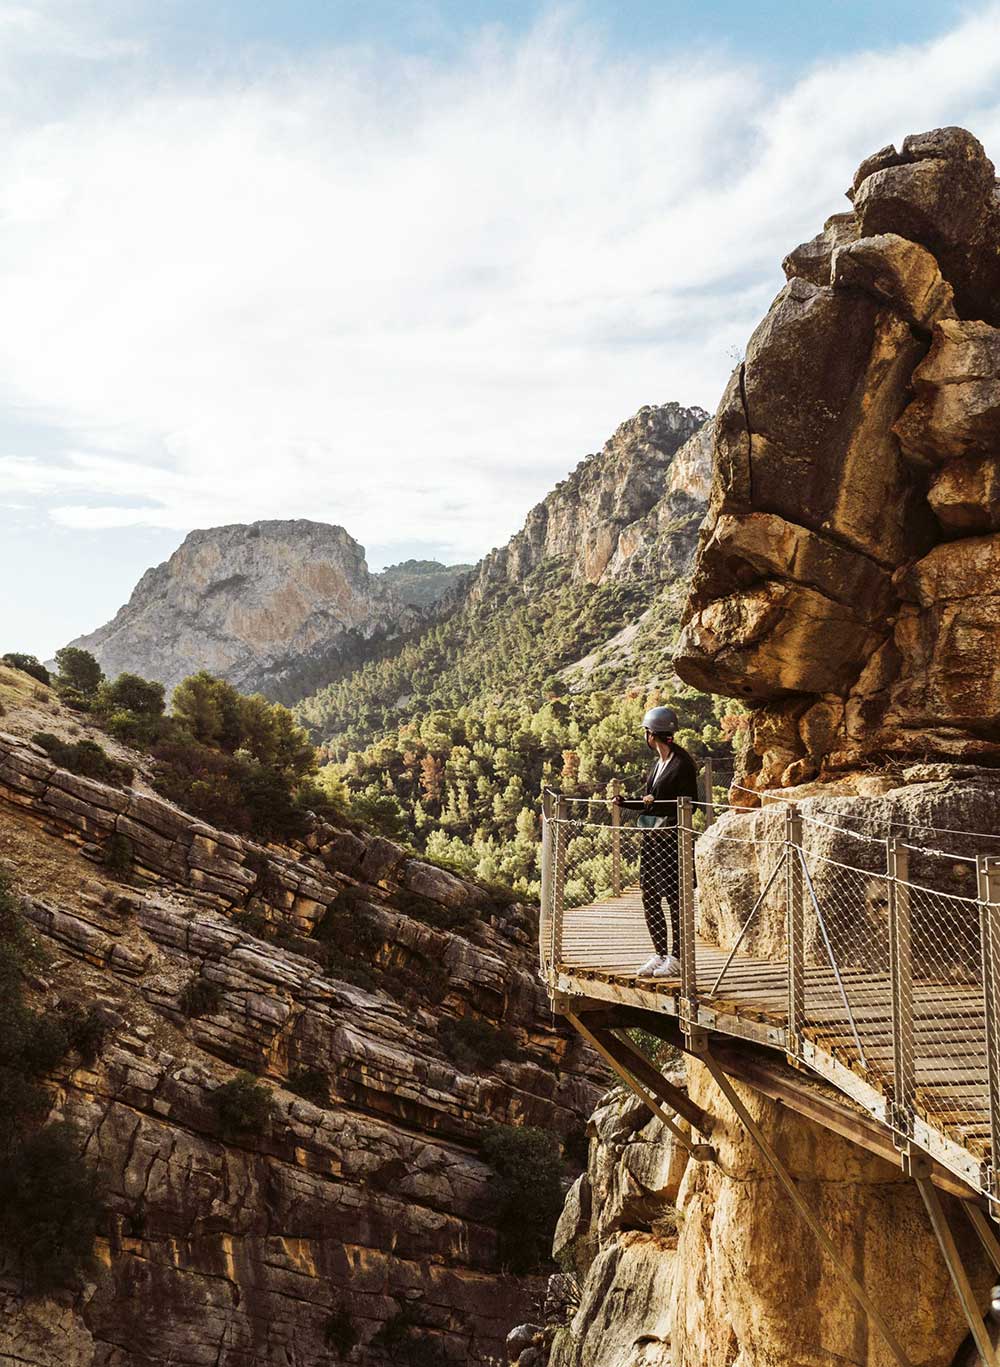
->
[471, 403, 710, 600]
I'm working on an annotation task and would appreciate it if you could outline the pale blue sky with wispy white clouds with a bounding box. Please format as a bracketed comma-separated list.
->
[0, 0, 1000, 658]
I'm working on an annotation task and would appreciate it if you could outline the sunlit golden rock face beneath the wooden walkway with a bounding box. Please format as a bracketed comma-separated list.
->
[538, 1061, 990, 1367]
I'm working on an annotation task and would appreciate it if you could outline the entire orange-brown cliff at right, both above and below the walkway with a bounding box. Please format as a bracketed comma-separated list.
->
[530, 128, 1000, 1367]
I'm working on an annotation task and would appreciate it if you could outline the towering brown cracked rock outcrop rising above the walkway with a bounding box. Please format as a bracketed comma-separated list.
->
[676, 128, 1000, 787]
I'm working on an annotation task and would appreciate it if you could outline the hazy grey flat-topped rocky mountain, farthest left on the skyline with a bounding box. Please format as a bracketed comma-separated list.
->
[64, 518, 464, 703]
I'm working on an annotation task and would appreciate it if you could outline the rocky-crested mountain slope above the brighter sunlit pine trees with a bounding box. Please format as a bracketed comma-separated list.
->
[296, 403, 712, 759]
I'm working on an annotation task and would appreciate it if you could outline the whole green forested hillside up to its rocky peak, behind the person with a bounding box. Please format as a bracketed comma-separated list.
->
[296, 405, 742, 897]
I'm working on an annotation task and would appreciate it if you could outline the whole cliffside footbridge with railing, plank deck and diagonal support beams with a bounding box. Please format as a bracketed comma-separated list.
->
[540, 793, 1000, 1367]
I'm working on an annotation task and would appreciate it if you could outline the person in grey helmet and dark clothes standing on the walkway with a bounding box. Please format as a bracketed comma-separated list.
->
[615, 707, 698, 977]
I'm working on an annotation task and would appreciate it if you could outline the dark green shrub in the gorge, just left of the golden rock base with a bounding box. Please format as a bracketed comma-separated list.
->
[482, 1125, 563, 1274]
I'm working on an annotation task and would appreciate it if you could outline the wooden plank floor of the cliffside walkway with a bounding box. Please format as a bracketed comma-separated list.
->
[556, 889, 990, 1188]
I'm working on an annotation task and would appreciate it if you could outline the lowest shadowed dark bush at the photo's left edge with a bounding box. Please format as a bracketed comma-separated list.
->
[0, 1125, 104, 1292]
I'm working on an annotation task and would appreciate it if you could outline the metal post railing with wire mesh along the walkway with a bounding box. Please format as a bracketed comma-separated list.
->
[540, 793, 1000, 1204]
